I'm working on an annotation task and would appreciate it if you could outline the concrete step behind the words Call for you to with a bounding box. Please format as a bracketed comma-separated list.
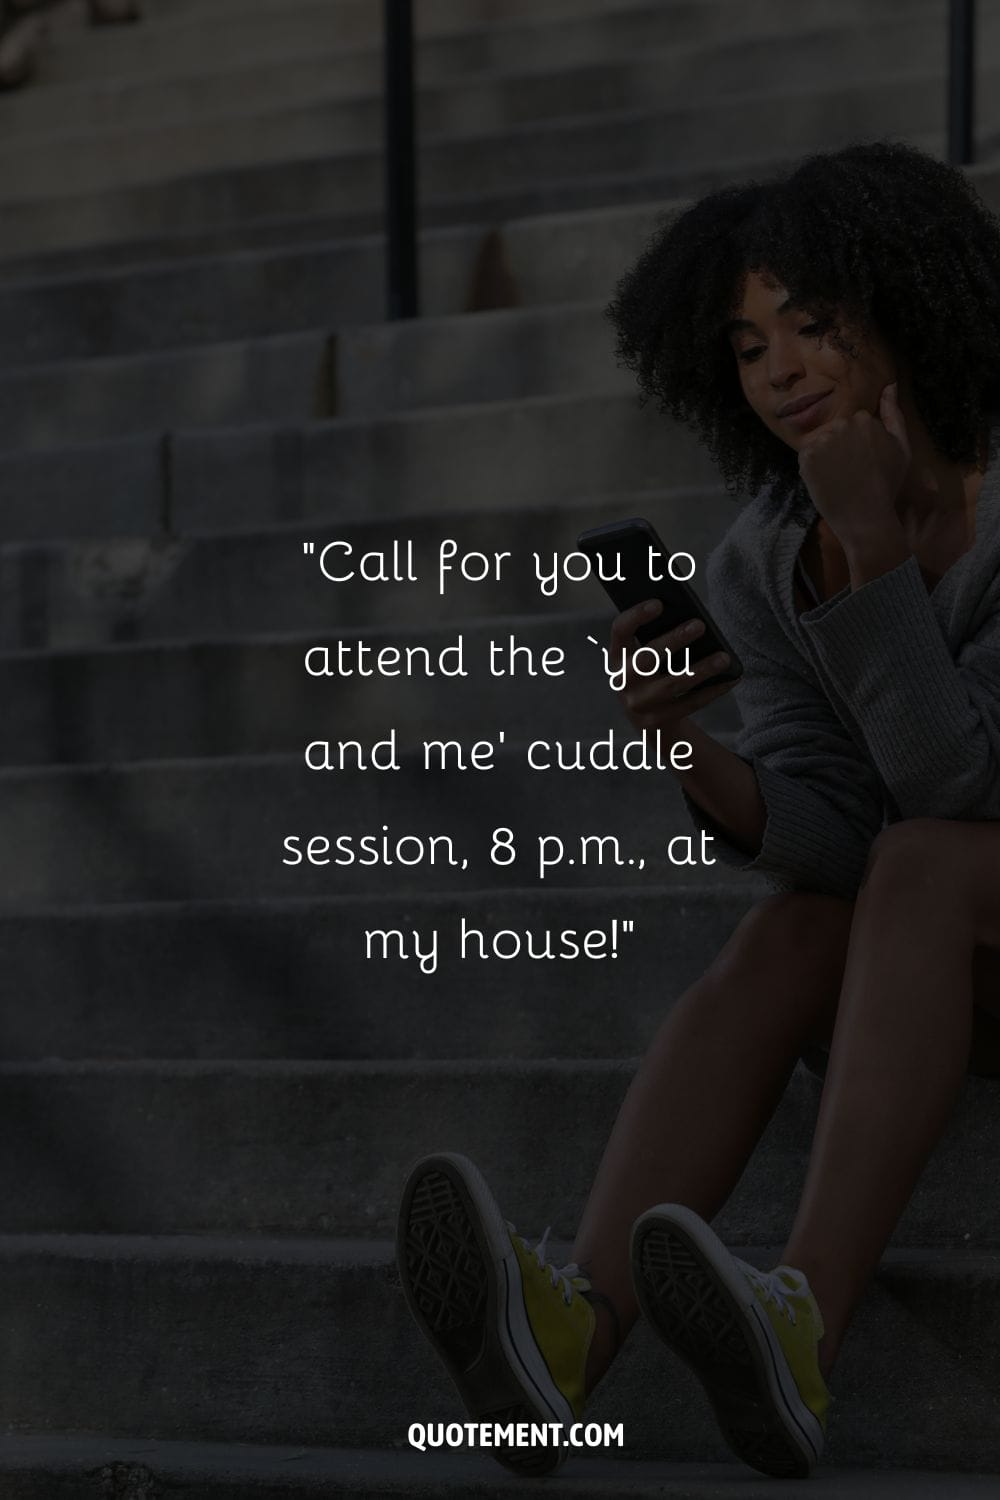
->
[0, 488, 739, 651]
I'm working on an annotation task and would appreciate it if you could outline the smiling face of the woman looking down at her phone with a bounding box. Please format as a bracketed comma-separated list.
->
[729, 272, 898, 449]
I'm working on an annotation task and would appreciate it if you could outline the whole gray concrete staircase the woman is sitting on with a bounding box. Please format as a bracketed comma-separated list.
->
[0, 0, 1000, 1500]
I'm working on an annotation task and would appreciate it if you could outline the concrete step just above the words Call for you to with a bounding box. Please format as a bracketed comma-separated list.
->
[0, 395, 718, 548]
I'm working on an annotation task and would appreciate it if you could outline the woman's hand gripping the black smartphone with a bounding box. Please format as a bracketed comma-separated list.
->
[610, 599, 736, 740]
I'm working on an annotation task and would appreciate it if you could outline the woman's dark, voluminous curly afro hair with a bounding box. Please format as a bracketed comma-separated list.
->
[606, 141, 1000, 498]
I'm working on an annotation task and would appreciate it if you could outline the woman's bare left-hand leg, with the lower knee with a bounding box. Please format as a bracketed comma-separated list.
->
[573, 894, 853, 1389]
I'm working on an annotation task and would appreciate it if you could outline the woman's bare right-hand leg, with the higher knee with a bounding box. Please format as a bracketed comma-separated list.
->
[783, 819, 1000, 1373]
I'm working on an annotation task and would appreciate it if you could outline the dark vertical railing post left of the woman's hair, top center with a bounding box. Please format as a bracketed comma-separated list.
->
[384, 0, 420, 320]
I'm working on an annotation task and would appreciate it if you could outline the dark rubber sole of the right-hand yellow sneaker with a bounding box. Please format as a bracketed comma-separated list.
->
[631, 1205, 823, 1479]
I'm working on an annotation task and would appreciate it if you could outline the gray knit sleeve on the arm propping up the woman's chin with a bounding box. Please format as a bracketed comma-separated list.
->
[802, 558, 1000, 819]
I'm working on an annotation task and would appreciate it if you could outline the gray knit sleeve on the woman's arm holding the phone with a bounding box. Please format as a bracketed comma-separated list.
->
[685, 539, 885, 899]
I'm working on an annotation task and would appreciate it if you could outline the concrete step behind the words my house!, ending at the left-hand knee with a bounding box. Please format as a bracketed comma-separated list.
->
[0, 876, 763, 1061]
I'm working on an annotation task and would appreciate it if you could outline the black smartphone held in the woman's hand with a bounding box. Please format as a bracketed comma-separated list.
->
[576, 516, 744, 687]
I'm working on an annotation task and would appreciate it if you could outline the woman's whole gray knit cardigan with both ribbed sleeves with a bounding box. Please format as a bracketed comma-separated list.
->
[685, 459, 1000, 897]
